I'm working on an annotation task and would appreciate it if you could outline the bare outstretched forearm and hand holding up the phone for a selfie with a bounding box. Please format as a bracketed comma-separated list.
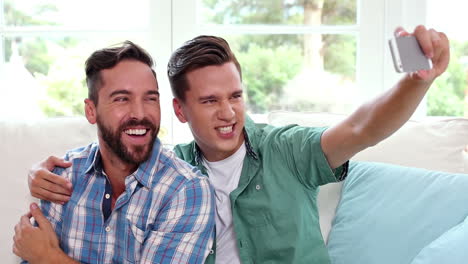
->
[321, 26, 450, 168]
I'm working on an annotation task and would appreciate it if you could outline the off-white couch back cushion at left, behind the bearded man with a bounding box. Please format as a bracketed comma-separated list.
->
[0, 117, 96, 263]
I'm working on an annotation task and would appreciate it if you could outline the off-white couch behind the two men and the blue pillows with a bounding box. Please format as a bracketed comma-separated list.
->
[0, 112, 468, 263]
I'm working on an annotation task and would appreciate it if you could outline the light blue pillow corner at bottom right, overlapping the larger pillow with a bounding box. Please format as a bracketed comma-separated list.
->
[411, 218, 468, 264]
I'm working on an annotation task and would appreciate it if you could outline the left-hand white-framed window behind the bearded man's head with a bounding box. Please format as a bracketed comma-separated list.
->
[0, 0, 171, 142]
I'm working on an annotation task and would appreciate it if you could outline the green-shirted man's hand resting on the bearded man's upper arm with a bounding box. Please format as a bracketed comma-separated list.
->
[28, 156, 72, 204]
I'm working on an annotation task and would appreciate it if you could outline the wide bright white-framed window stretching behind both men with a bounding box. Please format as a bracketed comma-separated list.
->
[0, 0, 468, 144]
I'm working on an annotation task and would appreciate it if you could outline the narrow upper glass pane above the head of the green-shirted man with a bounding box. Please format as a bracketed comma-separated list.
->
[198, 0, 356, 25]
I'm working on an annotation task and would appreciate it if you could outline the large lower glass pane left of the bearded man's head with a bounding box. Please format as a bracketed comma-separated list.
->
[0, 35, 148, 118]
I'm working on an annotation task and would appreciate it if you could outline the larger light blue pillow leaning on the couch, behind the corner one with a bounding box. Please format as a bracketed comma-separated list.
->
[327, 162, 468, 264]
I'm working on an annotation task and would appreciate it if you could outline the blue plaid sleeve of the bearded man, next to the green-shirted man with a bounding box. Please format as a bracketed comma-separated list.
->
[140, 175, 215, 264]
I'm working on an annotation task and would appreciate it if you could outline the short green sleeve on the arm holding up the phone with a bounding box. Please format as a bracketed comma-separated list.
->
[274, 125, 348, 188]
